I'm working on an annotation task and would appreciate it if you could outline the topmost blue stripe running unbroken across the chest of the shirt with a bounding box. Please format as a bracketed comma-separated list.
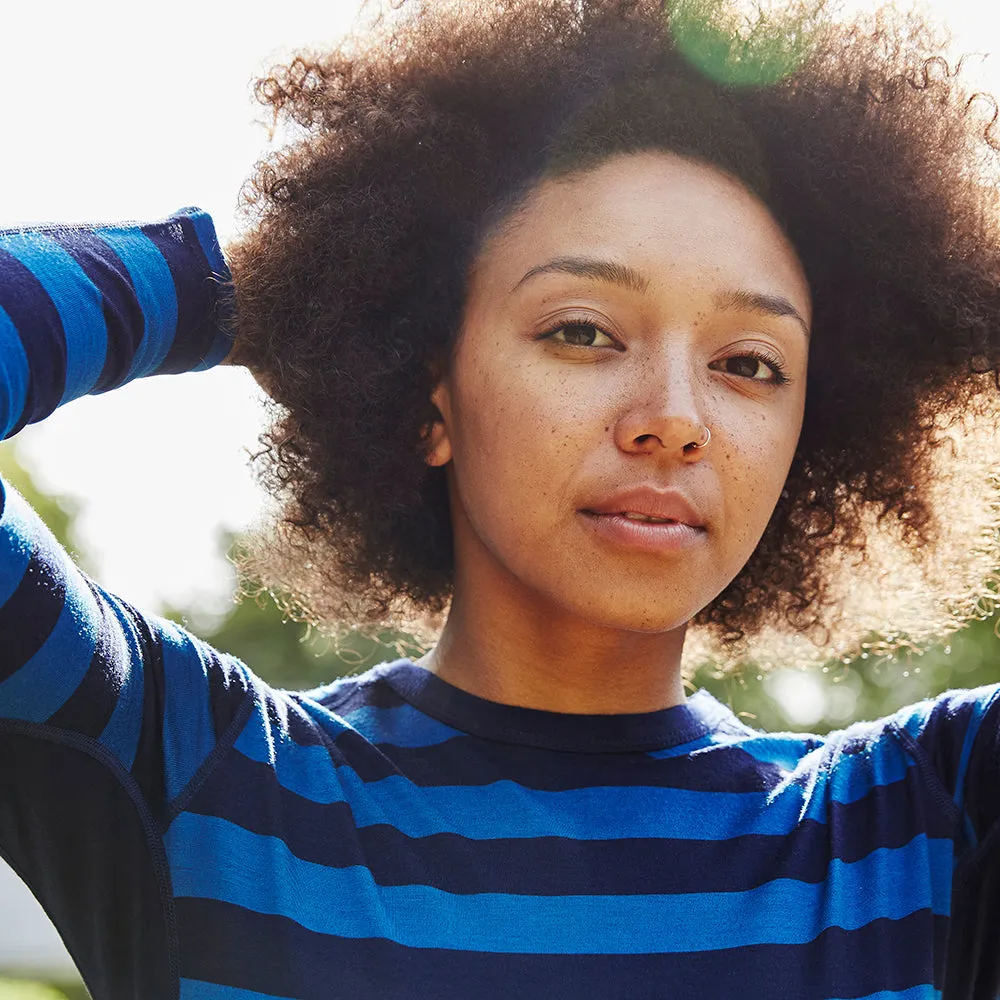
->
[230, 719, 905, 840]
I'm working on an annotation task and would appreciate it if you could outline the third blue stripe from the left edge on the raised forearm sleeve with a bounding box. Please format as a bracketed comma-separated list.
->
[95, 228, 177, 379]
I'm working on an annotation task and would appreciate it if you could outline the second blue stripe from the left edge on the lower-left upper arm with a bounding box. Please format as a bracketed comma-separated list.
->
[0, 549, 100, 722]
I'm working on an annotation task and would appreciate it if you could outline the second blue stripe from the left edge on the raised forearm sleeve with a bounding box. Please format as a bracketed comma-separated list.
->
[4, 232, 108, 405]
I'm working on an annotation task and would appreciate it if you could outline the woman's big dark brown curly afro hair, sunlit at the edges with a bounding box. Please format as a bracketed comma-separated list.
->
[228, 0, 1000, 662]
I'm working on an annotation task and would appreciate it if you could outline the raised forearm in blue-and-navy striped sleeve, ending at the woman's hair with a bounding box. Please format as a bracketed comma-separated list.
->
[0, 209, 232, 437]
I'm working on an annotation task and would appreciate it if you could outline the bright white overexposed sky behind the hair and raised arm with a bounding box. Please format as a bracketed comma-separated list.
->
[0, 0, 1000, 610]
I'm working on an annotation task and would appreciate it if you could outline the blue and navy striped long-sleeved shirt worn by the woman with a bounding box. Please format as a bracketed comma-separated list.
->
[0, 210, 1000, 1000]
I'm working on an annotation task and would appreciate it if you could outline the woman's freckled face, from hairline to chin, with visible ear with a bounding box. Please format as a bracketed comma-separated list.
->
[428, 152, 810, 632]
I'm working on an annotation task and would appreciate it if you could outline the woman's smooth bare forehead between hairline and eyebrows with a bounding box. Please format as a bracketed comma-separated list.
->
[472, 152, 809, 308]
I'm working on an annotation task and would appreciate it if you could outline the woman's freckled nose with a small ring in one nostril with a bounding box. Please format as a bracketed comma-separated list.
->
[615, 354, 709, 462]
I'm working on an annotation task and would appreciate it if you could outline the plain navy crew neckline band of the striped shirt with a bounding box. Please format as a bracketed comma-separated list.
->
[372, 660, 743, 753]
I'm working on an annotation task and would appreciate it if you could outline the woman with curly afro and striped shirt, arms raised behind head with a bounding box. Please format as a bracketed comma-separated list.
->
[0, 0, 1000, 1000]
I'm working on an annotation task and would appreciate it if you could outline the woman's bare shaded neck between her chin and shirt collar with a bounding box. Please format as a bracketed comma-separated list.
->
[419, 585, 685, 715]
